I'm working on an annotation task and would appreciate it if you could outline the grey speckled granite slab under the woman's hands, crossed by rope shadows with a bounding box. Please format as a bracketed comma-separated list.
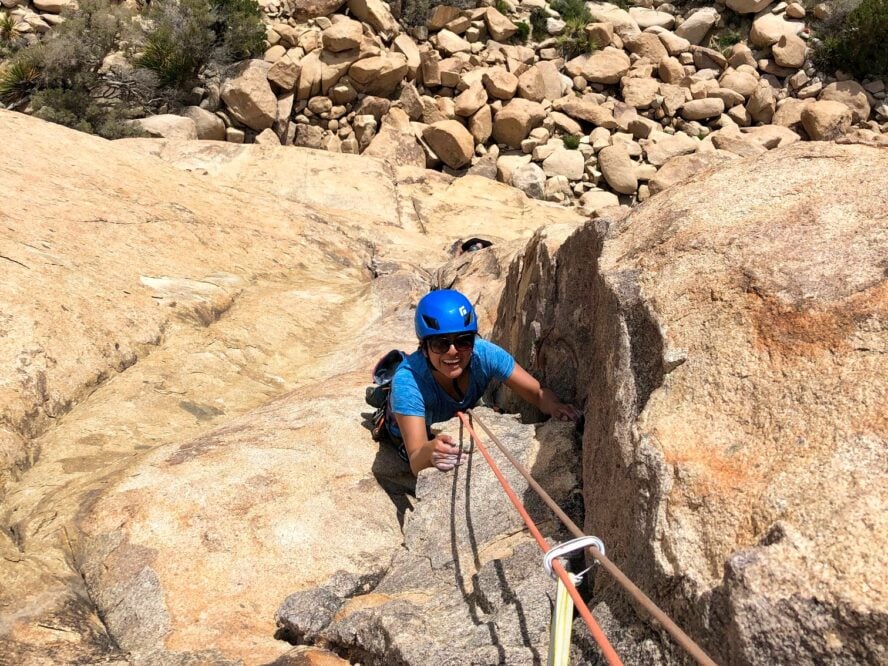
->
[278, 409, 584, 666]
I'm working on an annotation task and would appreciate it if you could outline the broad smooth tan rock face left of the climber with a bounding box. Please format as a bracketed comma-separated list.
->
[0, 111, 582, 665]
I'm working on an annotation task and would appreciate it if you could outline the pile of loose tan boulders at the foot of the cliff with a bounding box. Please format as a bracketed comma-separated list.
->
[0, 0, 888, 214]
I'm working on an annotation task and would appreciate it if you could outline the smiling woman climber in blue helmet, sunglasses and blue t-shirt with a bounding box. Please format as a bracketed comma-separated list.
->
[385, 289, 579, 474]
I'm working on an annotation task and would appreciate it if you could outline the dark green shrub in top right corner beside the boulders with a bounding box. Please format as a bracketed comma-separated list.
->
[814, 0, 888, 78]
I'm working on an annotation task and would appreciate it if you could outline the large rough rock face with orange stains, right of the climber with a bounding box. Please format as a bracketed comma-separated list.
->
[494, 143, 888, 664]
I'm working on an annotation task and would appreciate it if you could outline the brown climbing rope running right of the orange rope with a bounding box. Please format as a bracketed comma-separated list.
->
[459, 410, 716, 666]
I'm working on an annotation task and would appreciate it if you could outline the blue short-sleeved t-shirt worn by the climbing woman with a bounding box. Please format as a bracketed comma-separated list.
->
[389, 338, 515, 437]
